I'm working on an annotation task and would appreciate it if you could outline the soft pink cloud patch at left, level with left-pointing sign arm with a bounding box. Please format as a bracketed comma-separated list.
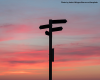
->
[0, 24, 32, 34]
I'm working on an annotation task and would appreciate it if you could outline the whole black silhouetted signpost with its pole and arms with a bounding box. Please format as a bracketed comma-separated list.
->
[39, 19, 67, 80]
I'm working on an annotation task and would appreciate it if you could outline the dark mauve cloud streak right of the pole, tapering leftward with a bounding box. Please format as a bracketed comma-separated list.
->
[57, 46, 100, 56]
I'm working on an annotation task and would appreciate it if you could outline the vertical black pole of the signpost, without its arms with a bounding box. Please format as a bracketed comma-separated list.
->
[49, 19, 52, 80]
